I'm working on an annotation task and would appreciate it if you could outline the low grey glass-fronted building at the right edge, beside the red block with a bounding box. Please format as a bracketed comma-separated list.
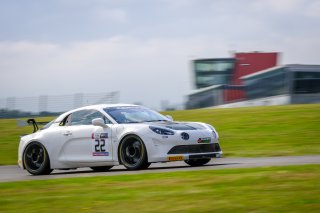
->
[241, 64, 320, 104]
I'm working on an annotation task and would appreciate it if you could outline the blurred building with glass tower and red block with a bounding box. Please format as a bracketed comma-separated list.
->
[186, 52, 279, 109]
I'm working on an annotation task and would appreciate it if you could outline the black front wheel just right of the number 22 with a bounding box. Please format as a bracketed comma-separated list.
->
[119, 135, 150, 170]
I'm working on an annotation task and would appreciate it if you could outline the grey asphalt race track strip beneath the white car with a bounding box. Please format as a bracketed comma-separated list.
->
[0, 155, 320, 182]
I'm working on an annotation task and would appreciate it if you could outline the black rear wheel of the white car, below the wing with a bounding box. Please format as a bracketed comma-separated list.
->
[23, 142, 53, 175]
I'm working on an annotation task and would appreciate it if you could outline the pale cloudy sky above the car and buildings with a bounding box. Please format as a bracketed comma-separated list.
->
[0, 0, 320, 109]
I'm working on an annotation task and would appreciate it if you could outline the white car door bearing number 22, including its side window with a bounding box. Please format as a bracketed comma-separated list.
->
[61, 110, 112, 166]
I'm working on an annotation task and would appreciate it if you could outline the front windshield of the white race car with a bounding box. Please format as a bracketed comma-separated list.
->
[104, 106, 169, 124]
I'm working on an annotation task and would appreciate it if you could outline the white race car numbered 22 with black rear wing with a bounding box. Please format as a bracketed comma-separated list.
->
[18, 104, 222, 175]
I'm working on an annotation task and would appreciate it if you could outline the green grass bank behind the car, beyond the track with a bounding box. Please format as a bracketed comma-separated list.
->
[0, 104, 320, 165]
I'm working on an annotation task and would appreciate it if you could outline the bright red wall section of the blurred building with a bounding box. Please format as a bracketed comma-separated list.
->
[224, 52, 279, 102]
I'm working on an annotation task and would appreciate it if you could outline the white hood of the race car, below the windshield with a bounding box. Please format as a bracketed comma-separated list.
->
[150, 121, 206, 130]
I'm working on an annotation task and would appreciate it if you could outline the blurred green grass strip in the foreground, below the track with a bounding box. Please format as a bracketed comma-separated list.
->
[0, 165, 320, 213]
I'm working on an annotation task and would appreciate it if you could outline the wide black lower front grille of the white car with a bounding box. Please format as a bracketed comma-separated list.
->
[168, 143, 221, 154]
